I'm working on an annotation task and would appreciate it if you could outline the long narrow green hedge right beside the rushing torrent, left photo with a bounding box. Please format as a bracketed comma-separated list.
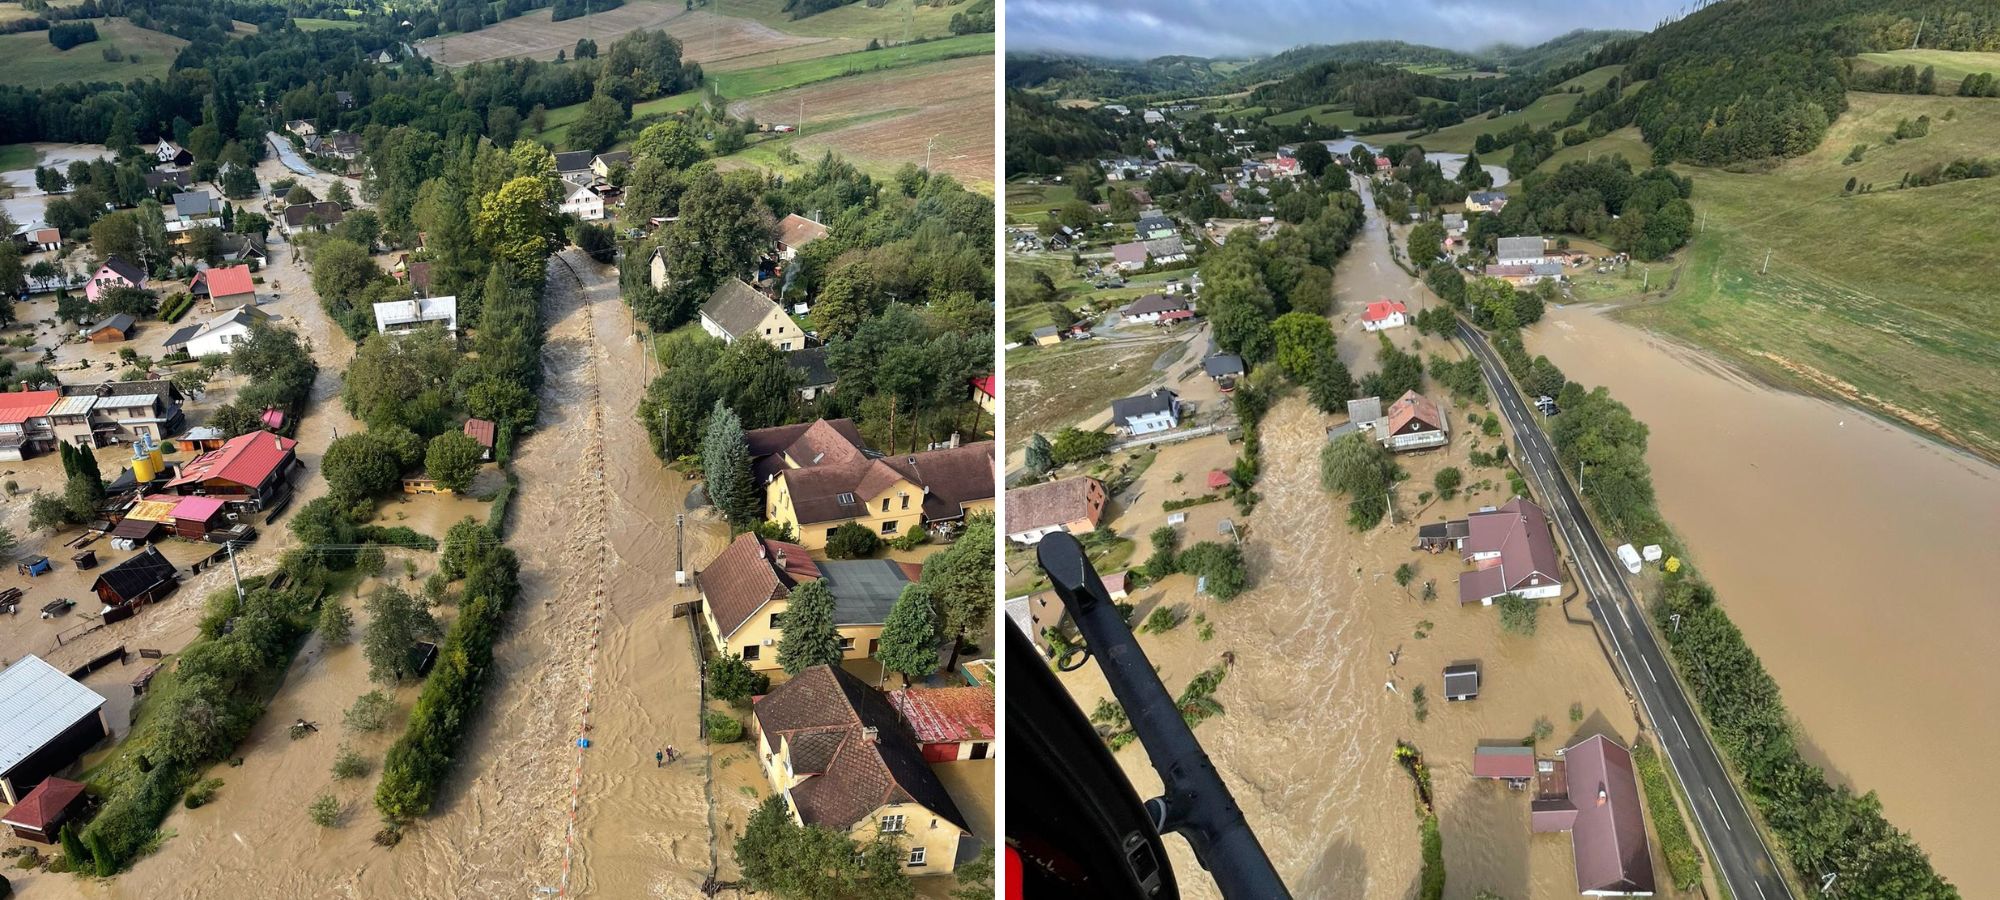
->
[376, 524, 520, 824]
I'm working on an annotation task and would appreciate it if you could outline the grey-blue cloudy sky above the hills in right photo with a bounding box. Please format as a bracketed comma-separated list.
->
[1006, 0, 1688, 58]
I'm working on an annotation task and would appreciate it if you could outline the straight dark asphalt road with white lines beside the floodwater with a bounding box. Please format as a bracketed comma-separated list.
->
[1458, 322, 1792, 900]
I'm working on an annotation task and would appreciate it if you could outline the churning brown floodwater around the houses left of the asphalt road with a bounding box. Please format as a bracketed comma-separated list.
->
[1064, 396, 1636, 900]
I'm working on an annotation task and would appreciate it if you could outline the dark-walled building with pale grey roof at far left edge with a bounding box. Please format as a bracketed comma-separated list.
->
[0, 654, 110, 804]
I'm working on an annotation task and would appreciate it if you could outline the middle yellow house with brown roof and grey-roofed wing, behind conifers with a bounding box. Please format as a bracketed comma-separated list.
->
[694, 534, 922, 670]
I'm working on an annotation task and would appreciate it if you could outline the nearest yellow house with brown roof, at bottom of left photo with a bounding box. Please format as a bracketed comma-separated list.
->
[754, 666, 970, 876]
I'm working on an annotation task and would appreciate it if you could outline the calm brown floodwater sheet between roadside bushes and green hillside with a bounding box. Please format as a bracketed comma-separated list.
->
[1528, 306, 2000, 896]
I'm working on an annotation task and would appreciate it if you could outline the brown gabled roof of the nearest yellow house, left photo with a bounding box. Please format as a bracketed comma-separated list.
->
[754, 666, 970, 832]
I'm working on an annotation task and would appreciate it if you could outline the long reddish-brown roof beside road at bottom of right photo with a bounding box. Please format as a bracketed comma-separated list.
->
[1562, 734, 1654, 894]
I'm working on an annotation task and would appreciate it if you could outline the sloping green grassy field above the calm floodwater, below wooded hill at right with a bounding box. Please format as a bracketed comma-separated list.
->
[1624, 94, 2000, 458]
